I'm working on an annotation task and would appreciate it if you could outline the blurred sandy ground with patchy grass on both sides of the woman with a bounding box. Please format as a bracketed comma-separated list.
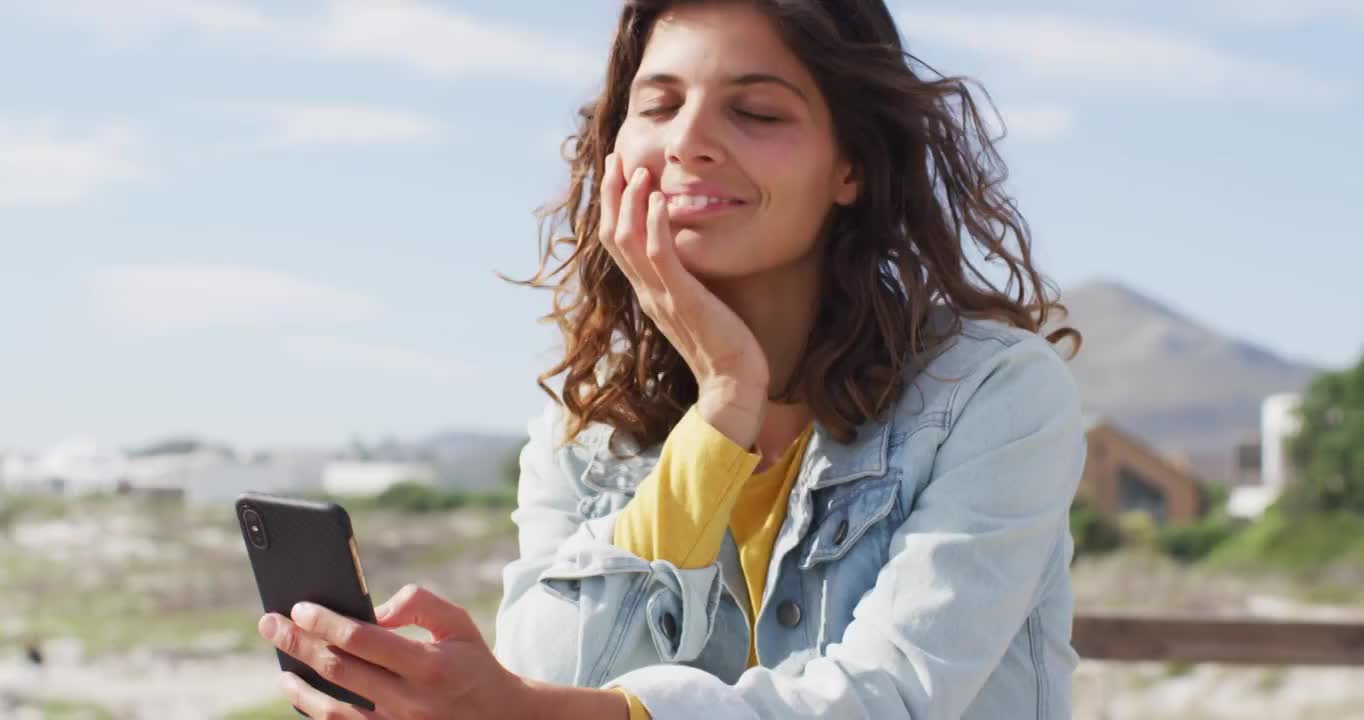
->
[0, 499, 1364, 720]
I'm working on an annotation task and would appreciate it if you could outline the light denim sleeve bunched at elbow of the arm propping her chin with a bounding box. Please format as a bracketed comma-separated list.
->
[494, 404, 747, 687]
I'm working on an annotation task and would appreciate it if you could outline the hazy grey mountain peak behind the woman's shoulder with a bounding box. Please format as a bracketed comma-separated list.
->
[1061, 282, 1318, 479]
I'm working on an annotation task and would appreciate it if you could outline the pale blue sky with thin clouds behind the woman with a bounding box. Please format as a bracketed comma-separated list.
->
[0, 0, 1364, 449]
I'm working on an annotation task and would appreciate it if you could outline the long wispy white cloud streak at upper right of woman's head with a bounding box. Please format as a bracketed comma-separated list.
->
[900, 5, 1338, 98]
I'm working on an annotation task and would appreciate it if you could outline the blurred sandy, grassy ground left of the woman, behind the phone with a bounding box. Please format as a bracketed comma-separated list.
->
[0, 498, 516, 720]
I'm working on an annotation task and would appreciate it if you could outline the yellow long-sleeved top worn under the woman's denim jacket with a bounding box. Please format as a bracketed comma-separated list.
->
[612, 406, 814, 720]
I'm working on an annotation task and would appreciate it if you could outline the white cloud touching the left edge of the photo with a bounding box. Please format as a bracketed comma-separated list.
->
[0, 119, 147, 207]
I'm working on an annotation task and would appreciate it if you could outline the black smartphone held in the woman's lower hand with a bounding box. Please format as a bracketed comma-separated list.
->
[236, 492, 375, 716]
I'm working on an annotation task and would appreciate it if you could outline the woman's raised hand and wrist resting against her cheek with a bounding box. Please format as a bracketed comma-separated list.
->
[597, 153, 771, 447]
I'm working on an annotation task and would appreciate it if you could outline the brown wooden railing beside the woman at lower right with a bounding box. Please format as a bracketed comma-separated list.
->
[1071, 614, 1364, 665]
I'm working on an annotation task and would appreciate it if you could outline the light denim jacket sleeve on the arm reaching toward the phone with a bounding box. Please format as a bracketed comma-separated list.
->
[611, 338, 1084, 720]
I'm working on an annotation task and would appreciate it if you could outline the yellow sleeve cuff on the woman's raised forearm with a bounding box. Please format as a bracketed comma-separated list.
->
[612, 405, 761, 567]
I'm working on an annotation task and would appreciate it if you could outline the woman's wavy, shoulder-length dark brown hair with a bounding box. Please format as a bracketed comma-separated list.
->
[513, 0, 1079, 447]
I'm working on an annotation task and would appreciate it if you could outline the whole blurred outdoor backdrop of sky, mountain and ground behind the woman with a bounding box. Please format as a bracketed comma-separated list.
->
[0, 0, 1364, 720]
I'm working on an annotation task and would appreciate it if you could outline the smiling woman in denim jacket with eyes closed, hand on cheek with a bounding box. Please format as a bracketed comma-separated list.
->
[263, 0, 1083, 720]
